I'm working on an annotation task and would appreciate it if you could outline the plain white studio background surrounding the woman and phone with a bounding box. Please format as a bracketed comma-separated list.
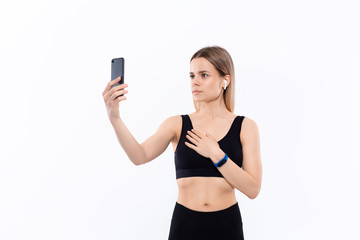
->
[0, 0, 360, 240]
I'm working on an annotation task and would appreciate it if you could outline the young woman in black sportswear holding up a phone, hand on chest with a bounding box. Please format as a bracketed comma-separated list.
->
[103, 46, 262, 240]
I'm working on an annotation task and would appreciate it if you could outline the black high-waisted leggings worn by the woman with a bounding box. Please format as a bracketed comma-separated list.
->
[169, 202, 244, 240]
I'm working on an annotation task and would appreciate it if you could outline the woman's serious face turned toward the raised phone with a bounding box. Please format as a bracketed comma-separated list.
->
[190, 57, 224, 101]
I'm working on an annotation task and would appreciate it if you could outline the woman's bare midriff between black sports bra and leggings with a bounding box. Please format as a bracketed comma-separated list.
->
[177, 177, 237, 212]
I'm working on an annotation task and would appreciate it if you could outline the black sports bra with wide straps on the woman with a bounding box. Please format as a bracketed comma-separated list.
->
[174, 114, 245, 179]
